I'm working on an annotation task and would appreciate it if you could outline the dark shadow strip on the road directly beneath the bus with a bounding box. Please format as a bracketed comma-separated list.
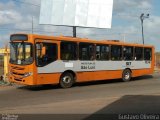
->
[17, 75, 153, 91]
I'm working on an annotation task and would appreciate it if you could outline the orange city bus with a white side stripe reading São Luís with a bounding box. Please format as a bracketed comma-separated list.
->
[9, 34, 155, 88]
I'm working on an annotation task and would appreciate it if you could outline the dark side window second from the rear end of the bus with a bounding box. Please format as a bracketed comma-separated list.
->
[135, 47, 143, 60]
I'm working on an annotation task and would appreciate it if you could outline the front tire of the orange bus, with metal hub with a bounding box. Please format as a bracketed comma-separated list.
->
[60, 72, 74, 88]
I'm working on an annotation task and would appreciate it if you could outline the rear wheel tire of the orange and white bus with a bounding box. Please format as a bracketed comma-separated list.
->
[122, 69, 131, 82]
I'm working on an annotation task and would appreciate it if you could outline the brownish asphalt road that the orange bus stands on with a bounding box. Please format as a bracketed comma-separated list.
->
[0, 73, 160, 119]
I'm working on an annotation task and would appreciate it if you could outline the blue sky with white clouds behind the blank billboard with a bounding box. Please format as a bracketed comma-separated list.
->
[0, 0, 160, 52]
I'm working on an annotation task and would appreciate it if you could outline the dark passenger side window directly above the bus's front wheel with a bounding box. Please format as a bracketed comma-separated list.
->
[61, 42, 77, 60]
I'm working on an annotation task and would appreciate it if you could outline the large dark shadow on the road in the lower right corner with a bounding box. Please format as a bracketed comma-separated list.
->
[86, 95, 160, 120]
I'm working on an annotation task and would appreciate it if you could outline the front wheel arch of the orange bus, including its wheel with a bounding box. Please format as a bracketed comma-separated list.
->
[59, 70, 76, 88]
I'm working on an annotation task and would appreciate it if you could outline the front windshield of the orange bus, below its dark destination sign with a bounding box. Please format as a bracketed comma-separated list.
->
[10, 42, 33, 65]
